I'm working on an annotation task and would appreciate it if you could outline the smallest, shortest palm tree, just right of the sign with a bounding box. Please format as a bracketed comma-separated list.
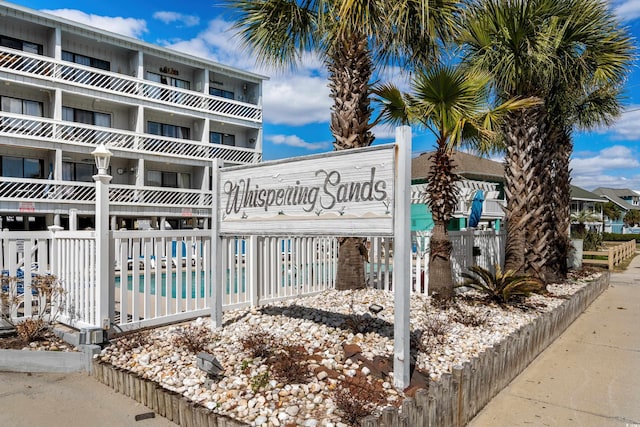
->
[374, 65, 536, 299]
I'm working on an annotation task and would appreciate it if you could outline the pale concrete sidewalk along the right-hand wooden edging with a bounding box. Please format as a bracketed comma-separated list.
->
[469, 256, 640, 427]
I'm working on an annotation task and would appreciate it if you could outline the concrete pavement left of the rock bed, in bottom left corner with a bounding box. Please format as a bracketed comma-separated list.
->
[0, 372, 175, 427]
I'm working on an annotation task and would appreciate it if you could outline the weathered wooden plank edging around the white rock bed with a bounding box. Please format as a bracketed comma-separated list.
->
[92, 273, 609, 427]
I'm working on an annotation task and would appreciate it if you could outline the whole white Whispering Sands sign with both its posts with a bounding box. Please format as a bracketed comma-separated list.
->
[211, 126, 411, 389]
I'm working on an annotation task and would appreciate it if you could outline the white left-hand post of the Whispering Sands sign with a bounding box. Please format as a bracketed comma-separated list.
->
[209, 159, 224, 328]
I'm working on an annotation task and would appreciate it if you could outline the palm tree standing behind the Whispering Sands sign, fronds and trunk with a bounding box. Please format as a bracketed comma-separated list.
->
[228, 0, 459, 289]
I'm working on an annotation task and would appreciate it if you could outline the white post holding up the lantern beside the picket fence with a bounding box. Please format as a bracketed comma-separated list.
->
[93, 173, 113, 330]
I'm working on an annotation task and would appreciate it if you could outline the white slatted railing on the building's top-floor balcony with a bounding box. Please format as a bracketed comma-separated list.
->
[0, 47, 262, 122]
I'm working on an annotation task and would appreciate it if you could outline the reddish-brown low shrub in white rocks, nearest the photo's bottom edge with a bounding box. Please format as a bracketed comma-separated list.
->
[333, 373, 386, 425]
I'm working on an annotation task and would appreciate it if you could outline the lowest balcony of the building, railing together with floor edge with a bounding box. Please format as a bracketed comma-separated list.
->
[0, 177, 213, 217]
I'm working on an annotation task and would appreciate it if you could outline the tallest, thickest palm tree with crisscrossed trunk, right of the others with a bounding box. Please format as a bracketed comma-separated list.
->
[461, 0, 631, 279]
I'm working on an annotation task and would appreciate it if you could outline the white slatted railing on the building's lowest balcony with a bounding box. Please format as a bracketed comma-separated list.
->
[0, 177, 212, 209]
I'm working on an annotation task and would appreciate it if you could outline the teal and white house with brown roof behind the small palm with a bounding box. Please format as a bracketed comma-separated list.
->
[411, 151, 505, 231]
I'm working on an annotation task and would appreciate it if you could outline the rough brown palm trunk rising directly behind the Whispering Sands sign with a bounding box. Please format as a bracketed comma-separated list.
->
[327, 33, 374, 290]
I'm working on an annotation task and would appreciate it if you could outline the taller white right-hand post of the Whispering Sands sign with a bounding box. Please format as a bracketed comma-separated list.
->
[393, 126, 411, 389]
